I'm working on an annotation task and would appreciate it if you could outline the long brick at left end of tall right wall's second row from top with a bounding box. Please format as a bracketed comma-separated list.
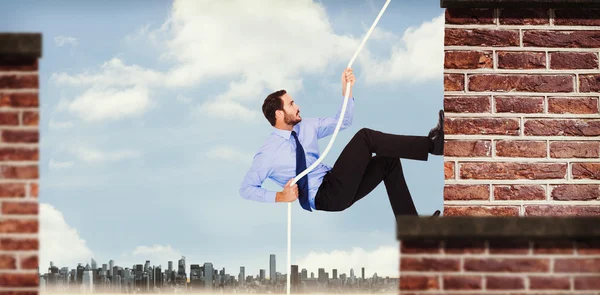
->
[444, 28, 520, 47]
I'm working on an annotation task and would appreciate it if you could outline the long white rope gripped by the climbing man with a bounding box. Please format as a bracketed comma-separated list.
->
[287, 0, 391, 295]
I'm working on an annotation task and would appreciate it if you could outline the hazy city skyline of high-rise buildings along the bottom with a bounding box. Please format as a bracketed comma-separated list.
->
[38, 254, 398, 293]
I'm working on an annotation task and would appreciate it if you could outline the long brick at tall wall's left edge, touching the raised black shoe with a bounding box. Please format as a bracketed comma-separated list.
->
[444, 118, 520, 135]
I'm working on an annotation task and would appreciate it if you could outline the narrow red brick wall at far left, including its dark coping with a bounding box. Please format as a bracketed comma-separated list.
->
[0, 34, 41, 295]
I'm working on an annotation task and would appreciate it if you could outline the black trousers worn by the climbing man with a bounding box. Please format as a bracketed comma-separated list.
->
[315, 128, 432, 216]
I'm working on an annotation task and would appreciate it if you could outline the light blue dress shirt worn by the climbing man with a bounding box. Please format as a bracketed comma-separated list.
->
[239, 97, 354, 209]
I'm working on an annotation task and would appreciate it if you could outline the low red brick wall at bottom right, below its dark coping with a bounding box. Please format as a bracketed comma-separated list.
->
[399, 240, 600, 295]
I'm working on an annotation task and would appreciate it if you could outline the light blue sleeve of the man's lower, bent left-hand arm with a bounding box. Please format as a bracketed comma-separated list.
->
[239, 152, 277, 203]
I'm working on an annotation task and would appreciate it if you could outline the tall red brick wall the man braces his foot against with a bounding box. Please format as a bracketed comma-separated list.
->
[444, 5, 600, 216]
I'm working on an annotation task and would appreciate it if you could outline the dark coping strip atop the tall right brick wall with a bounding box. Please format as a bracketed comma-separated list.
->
[440, 0, 600, 8]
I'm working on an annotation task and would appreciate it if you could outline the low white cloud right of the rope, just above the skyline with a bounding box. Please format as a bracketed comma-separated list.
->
[294, 246, 400, 277]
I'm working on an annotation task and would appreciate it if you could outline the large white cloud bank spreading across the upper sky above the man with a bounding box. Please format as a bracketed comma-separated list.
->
[52, 0, 444, 122]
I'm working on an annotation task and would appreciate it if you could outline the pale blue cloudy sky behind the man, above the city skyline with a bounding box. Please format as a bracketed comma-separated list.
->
[0, 0, 444, 277]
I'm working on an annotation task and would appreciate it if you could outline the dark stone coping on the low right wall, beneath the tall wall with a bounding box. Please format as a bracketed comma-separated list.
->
[396, 216, 600, 240]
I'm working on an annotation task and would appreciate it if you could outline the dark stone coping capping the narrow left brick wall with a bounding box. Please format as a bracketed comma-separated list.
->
[0, 33, 42, 59]
